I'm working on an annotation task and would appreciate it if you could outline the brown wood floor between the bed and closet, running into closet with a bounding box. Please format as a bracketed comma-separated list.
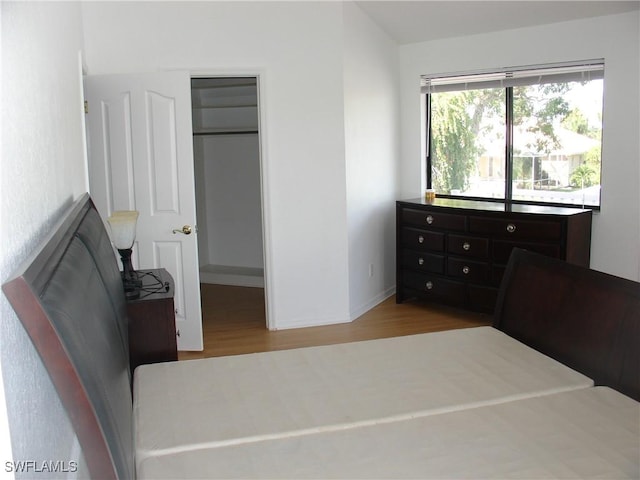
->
[179, 284, 491, 360]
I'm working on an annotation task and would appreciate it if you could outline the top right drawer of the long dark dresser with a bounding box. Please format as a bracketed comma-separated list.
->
[469, 217, 562, 240]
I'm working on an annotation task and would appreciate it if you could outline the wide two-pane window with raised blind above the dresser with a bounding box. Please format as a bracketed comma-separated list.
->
[422, 60, 604, 208]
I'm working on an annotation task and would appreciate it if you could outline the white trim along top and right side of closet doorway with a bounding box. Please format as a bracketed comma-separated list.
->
[188, 68, 276, 330]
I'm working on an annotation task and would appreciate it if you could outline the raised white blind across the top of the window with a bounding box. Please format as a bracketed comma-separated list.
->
[420, 59, 604, 93]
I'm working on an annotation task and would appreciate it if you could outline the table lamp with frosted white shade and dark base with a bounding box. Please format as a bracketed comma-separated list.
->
[107, 210, 142, 300]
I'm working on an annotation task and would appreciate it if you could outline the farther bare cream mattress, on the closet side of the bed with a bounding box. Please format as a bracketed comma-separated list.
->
[134, 327, 593, 462]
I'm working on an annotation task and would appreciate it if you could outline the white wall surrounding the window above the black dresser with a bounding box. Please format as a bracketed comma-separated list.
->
[400, 11, 640, 280]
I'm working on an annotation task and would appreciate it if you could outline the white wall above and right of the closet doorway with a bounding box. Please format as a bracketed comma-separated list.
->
[82, 2, 349, 328]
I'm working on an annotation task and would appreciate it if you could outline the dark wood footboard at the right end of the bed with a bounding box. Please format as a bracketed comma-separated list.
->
[494, 249, 640, 400]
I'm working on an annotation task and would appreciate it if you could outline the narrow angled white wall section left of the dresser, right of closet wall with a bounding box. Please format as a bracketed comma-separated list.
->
[344, 4, 399, 318]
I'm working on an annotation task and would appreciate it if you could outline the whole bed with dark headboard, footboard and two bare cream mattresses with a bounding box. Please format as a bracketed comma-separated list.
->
[3, 195, 640, 479]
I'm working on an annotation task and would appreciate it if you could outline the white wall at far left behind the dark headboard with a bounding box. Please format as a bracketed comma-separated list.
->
[0, 2, 87, 477]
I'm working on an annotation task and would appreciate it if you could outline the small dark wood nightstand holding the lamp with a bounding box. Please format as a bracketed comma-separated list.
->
[127, 268, 178, 373]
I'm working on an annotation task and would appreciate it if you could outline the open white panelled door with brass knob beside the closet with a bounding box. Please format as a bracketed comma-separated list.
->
[84, 72, 203, 350]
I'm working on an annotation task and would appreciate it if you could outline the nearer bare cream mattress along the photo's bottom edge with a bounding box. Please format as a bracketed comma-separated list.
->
[138, 387, 640, 479]
